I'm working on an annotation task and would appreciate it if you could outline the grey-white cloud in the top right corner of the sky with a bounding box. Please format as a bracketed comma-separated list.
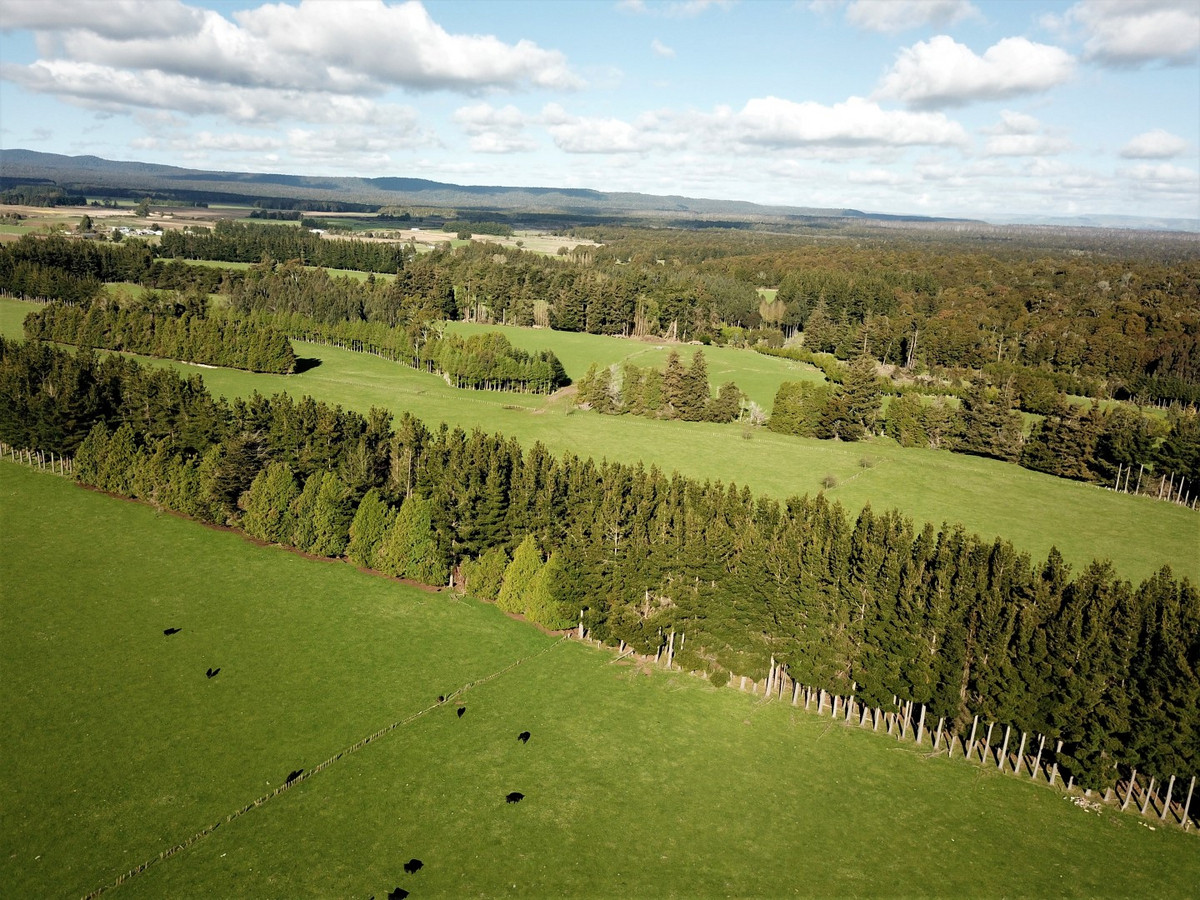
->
[1060, 0, 1200, 67]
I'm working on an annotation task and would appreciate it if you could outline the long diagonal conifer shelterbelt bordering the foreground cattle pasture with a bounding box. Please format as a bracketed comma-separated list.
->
[0, 341, 1200, 787]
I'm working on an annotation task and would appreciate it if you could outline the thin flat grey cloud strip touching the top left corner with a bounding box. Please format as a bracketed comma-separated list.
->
[0, 0, 204, 40]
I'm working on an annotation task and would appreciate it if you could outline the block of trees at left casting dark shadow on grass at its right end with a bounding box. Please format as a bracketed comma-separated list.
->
[25, 300, 296, 374]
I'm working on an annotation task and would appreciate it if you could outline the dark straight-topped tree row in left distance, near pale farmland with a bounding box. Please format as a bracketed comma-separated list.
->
[158, 220, 404, 272]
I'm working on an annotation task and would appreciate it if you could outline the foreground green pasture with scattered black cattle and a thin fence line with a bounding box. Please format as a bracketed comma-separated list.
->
[0, 463, 1200, 898]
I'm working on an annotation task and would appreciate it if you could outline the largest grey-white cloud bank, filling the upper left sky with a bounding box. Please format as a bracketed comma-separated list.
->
[2, 0, 582, 130]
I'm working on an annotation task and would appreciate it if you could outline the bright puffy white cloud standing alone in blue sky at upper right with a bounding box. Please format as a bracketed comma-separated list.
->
[877, 35, 1075, 108]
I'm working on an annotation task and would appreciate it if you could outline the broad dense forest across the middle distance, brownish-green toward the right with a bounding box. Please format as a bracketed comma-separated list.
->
[0, 222, 1200, 412]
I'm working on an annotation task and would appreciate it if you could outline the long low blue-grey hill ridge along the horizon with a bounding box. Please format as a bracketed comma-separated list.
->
[0, 150, 967, 223]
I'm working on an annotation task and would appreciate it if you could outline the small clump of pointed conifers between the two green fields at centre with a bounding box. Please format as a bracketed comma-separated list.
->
[575, 350, 744, 422]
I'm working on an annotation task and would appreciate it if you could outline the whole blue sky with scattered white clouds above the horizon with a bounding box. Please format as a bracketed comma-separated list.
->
[0, 0, 1200, 218]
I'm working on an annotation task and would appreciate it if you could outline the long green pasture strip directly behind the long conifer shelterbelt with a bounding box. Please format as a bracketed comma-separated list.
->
[0, 300, 1200, 581]
